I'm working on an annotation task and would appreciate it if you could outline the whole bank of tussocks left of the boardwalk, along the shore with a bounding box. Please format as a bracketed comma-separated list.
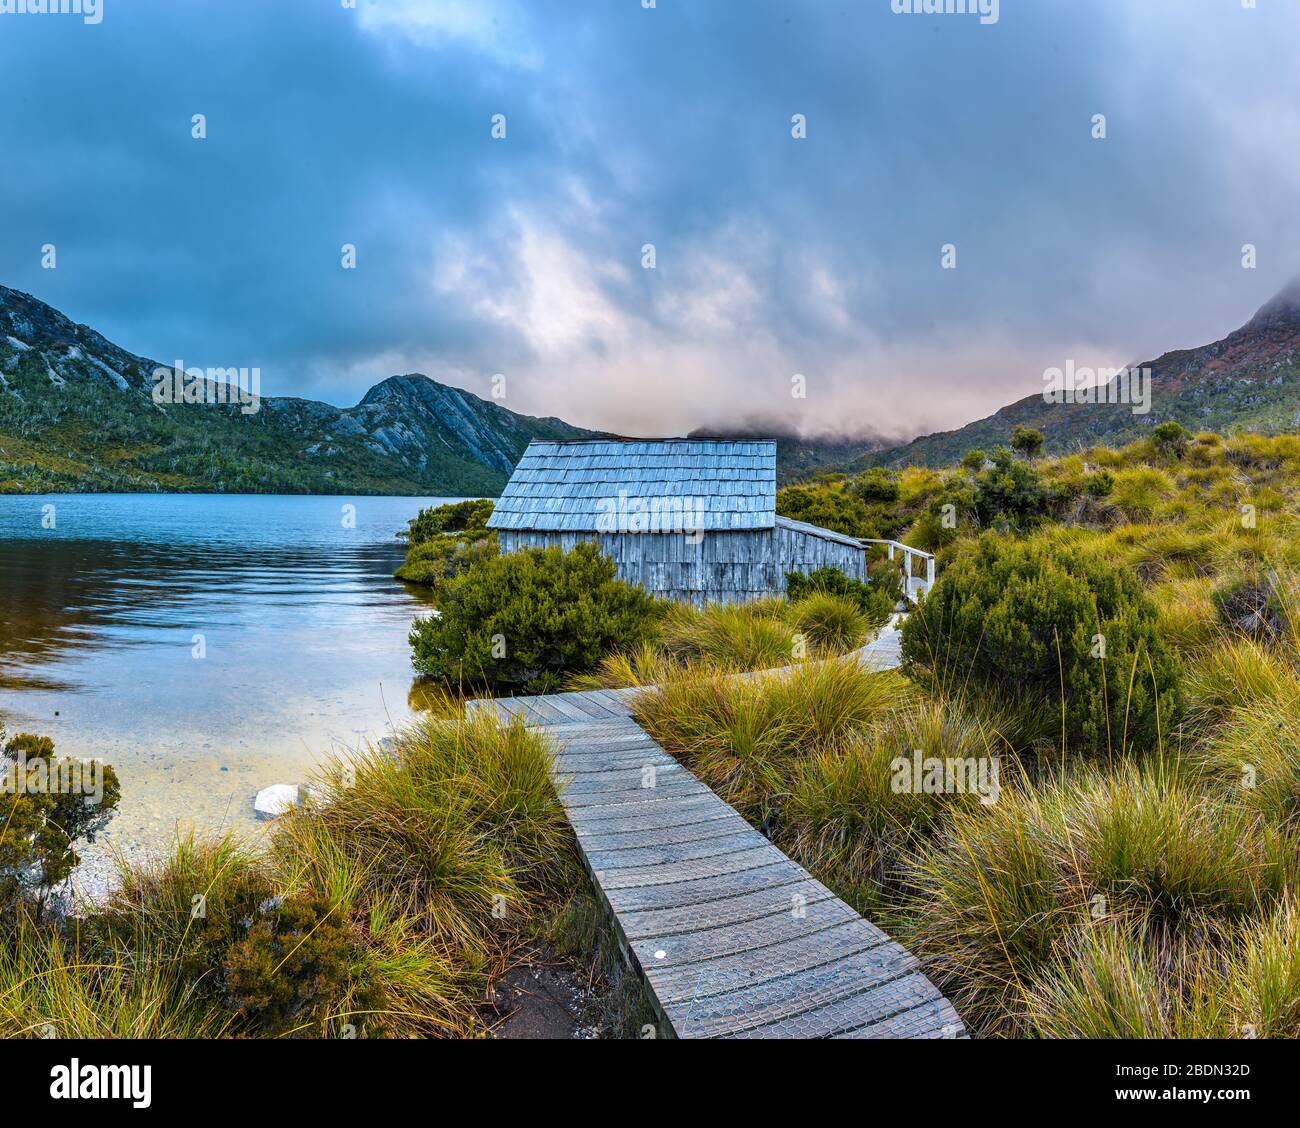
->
[0, 715, 581, 1037]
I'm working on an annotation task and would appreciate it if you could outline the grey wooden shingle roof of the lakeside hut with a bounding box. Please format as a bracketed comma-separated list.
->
[488, 439, 776, 533]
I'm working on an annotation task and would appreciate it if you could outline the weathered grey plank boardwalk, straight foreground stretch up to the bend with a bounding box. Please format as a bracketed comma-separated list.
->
[471, 632, 965, 1038]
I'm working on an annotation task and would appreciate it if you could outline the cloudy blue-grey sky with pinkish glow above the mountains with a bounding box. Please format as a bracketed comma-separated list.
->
[0, 0, 1300, 437]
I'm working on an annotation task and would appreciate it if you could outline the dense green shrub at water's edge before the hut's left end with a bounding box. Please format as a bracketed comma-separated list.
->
[411, 545, 660, 693]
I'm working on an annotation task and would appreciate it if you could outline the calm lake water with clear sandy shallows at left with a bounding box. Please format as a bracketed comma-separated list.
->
[0, 494, 457, 852]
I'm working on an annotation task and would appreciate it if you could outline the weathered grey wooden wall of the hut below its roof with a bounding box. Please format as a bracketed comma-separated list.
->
[497, 526, 866, 604]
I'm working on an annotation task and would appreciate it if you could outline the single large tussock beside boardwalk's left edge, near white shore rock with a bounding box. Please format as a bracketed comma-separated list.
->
[274, 713, 572, 956]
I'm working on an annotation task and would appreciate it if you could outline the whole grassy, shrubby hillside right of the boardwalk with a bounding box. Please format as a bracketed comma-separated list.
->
[638, 428, 1300, 1037]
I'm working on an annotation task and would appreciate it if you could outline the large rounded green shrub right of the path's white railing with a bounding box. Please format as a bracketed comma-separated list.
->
[902, 534, 1182, 752]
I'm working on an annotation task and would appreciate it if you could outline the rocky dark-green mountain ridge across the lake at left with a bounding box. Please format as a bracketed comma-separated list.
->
[0, 286, 592, 496]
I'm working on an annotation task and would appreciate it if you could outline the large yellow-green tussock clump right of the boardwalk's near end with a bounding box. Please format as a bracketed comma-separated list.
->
[909, 764, 1296, 1034]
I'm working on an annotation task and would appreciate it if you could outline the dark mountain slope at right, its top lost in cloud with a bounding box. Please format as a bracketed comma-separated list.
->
[845, 279, 1300, 470]
